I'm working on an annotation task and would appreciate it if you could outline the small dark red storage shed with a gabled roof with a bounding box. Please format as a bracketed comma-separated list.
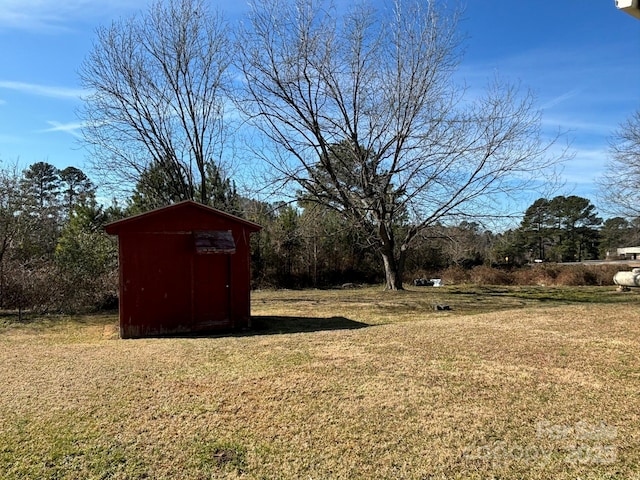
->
[105, 201, 261, 338]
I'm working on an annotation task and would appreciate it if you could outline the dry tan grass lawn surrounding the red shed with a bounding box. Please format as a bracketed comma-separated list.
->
[0, 286, 640, 479]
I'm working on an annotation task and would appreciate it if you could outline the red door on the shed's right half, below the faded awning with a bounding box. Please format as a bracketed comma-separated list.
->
[193, 254, 231, 329]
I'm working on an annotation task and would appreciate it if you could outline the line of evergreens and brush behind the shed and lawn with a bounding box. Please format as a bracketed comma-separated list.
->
[0, 162, 640, 312]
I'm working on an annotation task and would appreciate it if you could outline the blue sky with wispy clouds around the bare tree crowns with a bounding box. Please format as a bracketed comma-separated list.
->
[0, 0, 640, 212]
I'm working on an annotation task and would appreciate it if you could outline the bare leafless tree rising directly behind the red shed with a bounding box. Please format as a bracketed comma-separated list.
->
[80, 0, 233, 203]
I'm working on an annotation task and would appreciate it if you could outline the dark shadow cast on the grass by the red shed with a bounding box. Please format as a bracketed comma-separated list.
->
[250, 315, 369, 335]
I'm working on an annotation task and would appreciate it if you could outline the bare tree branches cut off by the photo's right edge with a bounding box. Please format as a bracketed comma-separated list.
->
[599, 109, 640, 218]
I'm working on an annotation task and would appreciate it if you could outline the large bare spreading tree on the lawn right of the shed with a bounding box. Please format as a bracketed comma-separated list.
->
[238, 0, 557, 289]
